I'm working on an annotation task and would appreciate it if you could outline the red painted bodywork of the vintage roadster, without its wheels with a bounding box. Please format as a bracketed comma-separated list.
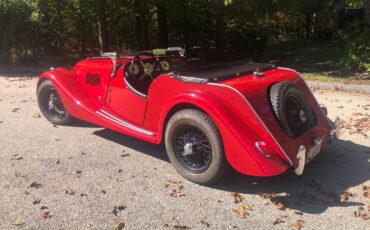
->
[39, 54, 335, 176]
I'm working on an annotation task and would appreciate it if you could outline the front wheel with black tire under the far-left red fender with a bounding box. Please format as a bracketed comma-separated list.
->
[37, 80, 73, 125]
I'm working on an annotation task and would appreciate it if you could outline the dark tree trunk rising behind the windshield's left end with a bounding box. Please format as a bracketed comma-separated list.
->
[98, 0, 109, 54]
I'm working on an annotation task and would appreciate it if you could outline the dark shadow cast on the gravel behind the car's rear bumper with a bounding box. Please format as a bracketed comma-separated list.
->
[212, 140, 370, 214]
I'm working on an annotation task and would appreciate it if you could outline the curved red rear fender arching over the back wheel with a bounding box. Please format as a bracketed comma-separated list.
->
[158, 91, 288, 176]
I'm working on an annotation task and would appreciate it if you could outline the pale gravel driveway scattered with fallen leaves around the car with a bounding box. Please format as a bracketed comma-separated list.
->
[0, 77, 370, 229]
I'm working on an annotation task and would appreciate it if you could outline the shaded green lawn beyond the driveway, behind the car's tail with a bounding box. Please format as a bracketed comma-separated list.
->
[262, 40, 370, 85]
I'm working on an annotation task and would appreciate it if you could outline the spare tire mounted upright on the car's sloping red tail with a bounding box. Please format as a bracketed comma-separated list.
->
[270, 82, 316, 138]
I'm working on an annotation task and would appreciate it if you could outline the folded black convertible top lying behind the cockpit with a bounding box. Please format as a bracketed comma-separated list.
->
[172, 61, 276, 82]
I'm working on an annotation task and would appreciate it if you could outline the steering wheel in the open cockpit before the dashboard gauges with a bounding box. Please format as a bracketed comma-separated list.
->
[128, 52, 160, 80]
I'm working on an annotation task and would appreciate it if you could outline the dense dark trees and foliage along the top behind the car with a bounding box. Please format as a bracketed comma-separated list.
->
[0, 0, 370, 68]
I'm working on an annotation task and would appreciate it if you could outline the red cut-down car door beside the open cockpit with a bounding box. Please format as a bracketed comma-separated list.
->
[104, 67, 147, 125]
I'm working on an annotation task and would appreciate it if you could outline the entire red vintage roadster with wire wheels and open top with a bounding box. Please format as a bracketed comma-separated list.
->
[37, 48, 339, 184]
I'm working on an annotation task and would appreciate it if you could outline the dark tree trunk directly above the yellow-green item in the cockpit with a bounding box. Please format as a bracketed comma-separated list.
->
[157, 0, 168, 48]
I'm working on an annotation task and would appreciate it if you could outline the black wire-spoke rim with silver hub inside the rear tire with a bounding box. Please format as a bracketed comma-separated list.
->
[173, 124, 212, 173]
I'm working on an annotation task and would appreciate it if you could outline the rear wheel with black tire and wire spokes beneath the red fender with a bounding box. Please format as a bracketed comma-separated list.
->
[165, 109, 230, 185]
